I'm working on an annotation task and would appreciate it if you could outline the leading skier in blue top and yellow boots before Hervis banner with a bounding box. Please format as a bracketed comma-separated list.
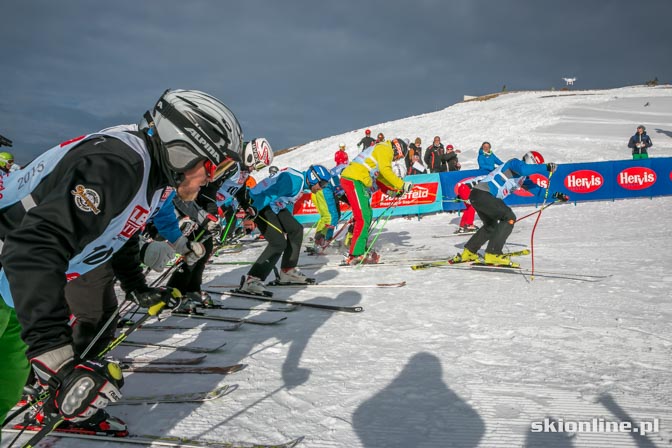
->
[451, 151, 569, 267]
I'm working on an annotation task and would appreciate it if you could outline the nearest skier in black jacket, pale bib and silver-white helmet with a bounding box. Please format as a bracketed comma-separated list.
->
[0, 90, 242, 432]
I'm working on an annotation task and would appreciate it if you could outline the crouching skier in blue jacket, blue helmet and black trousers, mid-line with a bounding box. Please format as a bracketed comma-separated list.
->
[239, 165, 331, 295]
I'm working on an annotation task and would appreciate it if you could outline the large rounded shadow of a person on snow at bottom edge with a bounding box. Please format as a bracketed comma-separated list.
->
[352, 352, 485, 448]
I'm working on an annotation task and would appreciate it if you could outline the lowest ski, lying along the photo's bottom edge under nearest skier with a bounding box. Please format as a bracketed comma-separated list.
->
[2, 429, 304, 448]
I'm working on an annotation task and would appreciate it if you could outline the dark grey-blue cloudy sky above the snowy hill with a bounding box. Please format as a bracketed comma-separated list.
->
[0, 0, 672, 163]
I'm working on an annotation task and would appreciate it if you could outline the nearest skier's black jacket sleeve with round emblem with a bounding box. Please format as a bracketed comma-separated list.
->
[2, 138, 143, 357]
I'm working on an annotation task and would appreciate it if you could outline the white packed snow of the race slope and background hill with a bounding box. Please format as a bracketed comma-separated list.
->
[2, 86, 672, 448]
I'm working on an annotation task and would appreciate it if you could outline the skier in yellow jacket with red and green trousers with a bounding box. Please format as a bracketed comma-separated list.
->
[341, 138, 413, 264]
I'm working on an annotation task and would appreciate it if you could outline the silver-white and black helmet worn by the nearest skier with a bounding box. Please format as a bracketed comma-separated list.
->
[140, 89, 243, 186]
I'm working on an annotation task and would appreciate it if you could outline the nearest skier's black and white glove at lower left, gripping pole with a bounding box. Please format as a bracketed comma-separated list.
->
[30, 345, 124, 422]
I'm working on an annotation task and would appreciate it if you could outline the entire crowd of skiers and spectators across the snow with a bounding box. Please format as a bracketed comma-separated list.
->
[6, 90, 650, 440]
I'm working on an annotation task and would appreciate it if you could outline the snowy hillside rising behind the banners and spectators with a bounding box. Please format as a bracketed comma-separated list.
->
[262, 85, 672, 175]
